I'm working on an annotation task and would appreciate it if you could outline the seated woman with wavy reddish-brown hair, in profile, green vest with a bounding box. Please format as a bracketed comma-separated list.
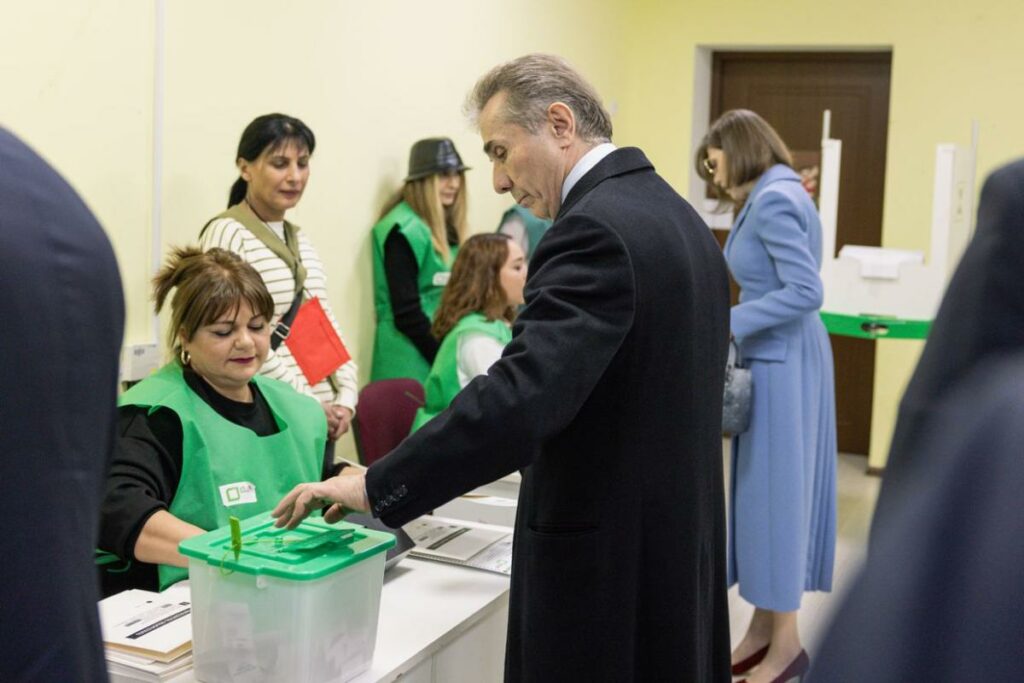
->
[413, 233, 526, 432]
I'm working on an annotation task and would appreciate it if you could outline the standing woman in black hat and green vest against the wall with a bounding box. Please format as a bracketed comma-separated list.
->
[370, 137, 468, 382]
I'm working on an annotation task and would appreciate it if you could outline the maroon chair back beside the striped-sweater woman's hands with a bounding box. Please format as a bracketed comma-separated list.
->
[352, 378, 424, 466]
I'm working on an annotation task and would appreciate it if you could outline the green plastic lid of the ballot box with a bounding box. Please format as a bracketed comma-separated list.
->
[178, 512, 395, 581]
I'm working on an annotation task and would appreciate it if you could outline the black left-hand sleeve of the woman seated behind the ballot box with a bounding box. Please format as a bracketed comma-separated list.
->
[98, 405, 182, 560]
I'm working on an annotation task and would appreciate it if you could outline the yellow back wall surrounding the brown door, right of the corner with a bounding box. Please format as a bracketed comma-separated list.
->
[616, 0, 1024, 466]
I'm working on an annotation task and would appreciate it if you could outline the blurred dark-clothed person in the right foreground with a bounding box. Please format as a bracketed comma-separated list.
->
[810, 160, 1024, 683]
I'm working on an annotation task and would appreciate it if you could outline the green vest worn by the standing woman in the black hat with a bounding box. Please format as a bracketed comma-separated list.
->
[370, 202, 458, 382]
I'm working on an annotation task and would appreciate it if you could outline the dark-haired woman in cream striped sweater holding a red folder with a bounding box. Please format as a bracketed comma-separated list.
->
[200, 114, 358, 447]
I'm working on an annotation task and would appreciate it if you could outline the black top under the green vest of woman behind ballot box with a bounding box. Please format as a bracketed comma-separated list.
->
[97, 368, 337, 595]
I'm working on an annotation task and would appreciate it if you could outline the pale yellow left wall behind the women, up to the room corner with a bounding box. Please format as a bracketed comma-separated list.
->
[0, 0, 622, 455]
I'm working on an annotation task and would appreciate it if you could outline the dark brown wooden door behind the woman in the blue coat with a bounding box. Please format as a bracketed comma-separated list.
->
[711, 52, 892, 455]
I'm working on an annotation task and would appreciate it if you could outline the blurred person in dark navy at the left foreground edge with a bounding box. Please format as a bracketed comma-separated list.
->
[0, 129, 124, 681]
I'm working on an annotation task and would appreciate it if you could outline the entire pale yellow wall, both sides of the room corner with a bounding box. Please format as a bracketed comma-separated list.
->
[0, 0, 1024, 463]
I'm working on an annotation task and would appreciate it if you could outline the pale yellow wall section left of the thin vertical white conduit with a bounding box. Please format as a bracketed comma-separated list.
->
[0, 0, 153, 340]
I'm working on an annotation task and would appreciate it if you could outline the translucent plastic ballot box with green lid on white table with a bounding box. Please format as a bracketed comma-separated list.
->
[179, 513, 395, 683]
